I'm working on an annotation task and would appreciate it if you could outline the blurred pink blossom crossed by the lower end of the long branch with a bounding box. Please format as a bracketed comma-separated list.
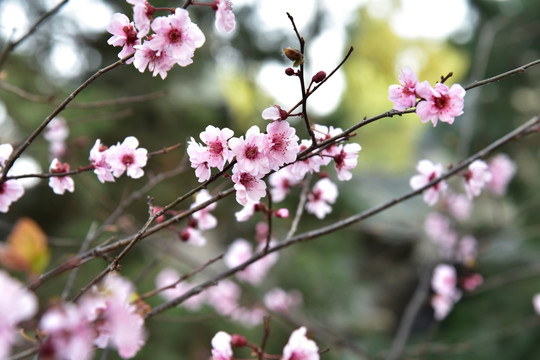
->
[155, 268, 206, 311]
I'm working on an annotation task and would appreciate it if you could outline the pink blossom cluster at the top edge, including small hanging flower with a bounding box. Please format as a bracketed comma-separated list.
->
[107, 0, 235, 79]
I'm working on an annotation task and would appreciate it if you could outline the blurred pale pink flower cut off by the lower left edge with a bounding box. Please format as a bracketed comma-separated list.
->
[0, 270, 38, 359]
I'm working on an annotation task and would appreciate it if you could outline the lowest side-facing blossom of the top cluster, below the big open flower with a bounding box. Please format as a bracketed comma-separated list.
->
[133, 41, 176, 80]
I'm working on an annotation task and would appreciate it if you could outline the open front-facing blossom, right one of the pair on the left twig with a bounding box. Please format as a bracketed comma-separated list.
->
[106, 136, 148, 179]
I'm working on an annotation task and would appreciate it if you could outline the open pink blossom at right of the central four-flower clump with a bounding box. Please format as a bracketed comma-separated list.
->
[266, 121, 300, 170]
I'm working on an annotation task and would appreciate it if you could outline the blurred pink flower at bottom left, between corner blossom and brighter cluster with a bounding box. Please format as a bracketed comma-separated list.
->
[39, 303, 95, 360]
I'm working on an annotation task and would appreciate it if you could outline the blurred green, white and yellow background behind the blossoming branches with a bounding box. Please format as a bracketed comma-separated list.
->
[0, 0, 540, 359]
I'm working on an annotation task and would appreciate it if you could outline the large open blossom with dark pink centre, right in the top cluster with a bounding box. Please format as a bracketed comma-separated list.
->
[147, 8, 205, 66]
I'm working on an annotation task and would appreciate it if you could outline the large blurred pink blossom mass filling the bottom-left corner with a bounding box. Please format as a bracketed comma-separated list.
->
[0, 272, 146, 360]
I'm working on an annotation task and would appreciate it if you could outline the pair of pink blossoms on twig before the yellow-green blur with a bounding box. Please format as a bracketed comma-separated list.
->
[388, 67, 465, 126]
